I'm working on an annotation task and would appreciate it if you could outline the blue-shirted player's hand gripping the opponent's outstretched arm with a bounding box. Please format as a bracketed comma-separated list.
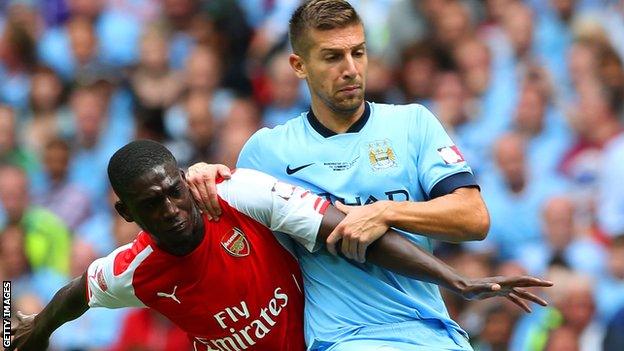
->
[326, 201, 389, 263]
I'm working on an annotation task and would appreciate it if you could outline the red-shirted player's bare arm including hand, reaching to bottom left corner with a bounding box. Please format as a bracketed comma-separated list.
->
[7, 273, 89, 351]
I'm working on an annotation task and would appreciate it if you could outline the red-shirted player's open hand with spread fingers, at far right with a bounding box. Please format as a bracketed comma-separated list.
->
[460, 276, 553, 313]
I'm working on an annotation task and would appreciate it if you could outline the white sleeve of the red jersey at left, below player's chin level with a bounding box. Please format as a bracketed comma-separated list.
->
[87, 244, 147, 308]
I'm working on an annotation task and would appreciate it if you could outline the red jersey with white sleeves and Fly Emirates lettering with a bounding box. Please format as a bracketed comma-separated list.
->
[87, 169, 329, 351]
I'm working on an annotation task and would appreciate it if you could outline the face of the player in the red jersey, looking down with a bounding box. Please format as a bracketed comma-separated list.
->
[119, 164, 201, 249]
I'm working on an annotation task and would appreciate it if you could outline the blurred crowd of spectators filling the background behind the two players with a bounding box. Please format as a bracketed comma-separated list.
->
[0, 0, 624, 351]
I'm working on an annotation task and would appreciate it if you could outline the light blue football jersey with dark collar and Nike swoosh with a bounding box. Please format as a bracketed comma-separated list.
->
[237, 102, 476, 350]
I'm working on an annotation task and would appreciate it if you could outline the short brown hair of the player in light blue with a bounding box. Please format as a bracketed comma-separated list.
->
[288, 0, 362, 55]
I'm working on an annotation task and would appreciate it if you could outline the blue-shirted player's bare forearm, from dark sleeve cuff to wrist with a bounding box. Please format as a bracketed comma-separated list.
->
[380, 188, 489, 242]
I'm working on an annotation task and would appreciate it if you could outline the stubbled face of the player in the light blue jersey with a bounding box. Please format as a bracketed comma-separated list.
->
[297, 24, 368, 113]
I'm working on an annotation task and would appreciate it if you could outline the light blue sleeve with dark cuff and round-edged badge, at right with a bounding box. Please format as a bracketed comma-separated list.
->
[409, 105, 477, 199]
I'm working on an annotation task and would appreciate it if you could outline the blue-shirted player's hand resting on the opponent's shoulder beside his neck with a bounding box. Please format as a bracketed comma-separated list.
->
[186, 162, 232, 220]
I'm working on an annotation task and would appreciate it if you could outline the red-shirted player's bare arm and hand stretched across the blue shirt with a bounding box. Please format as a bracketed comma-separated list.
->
[317, 206, 552, 312]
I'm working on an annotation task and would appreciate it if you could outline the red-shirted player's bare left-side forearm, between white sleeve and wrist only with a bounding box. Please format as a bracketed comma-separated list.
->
[34, 273, 89, 336]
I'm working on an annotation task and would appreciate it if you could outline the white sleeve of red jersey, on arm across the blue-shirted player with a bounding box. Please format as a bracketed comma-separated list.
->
[217, 168, 330, 252]
